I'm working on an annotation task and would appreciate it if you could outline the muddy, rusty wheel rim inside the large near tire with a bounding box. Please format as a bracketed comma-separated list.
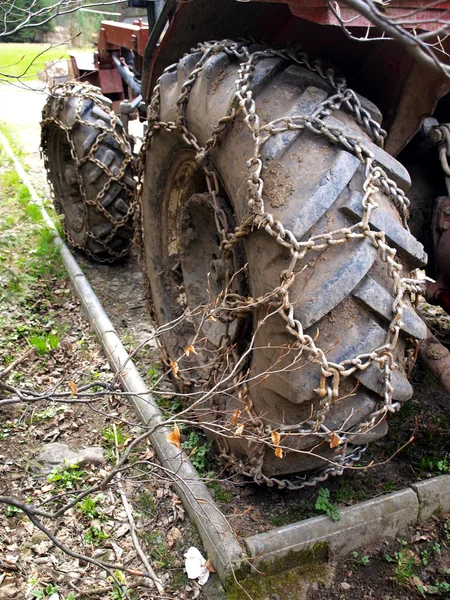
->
[161, 151, 248, 366]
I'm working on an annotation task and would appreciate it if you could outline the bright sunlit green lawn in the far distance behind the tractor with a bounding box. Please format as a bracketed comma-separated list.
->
[0, 44, 69, 81]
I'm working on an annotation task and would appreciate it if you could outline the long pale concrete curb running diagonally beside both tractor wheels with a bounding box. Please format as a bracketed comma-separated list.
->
[0, 133, 243, 581]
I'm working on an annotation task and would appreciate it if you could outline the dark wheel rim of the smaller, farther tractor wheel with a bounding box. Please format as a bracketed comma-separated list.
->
[49, 128, 87, 244]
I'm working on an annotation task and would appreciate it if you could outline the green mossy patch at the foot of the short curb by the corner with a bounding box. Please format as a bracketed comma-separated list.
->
[225, 543, 329, 600]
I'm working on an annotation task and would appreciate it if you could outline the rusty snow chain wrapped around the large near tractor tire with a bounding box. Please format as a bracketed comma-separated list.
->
[137, 40, 423, 490]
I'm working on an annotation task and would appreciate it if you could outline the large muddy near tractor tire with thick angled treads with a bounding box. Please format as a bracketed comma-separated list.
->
[140, 44, 426, 482]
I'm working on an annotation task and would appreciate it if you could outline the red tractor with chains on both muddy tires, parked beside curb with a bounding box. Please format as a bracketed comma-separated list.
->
[42, 0, 450, 489]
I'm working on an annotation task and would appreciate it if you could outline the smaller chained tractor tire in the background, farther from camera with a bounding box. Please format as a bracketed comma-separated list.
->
[41, 83, 135, 262]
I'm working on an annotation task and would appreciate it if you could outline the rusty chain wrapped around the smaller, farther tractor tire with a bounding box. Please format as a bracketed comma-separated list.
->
[40, 82, 136, 263]
